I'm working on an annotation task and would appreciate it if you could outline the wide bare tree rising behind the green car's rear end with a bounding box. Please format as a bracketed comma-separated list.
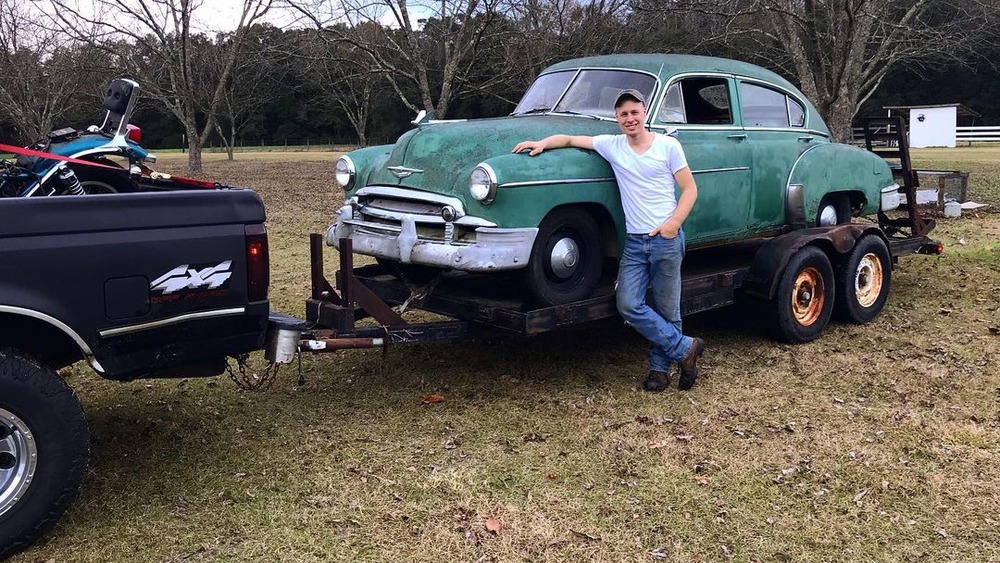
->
[639, 0, 997, 140]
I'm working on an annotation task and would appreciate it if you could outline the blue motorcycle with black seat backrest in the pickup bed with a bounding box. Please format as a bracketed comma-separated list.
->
[0, 78, 156, 197]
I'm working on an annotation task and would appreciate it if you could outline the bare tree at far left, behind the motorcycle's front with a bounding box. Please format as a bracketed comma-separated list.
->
[0, 0, 108, 144]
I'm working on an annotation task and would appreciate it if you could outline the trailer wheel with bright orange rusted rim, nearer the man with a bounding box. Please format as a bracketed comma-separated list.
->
[772, 246, 835, 343]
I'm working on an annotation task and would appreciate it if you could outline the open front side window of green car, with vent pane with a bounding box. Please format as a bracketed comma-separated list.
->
[656, 77, 733, 125]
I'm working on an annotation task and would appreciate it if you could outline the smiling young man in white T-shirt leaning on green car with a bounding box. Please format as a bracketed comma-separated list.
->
[513, 89, 705, 391]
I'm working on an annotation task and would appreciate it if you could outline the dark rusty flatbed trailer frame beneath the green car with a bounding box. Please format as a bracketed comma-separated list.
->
[272, 224, 942, 361]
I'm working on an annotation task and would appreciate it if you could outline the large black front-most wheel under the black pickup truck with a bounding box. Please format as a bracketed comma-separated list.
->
[0, 348, 90, 559]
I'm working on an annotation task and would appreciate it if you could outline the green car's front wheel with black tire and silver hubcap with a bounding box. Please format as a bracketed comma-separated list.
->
[526, 208, 603, 306]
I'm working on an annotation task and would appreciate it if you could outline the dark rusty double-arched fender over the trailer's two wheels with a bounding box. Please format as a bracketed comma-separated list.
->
[743, 227, 889, 299]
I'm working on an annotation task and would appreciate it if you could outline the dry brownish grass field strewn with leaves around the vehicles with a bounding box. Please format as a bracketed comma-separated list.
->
[14, 148, 1000, 563]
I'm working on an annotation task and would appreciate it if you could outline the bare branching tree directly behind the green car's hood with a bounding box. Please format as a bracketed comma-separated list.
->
[288, 0, 501, 118]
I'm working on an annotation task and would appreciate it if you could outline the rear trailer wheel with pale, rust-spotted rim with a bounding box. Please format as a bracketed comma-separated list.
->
[836, 235, 892, 324]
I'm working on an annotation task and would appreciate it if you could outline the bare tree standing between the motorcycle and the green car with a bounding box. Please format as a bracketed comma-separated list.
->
[50, 0, 274, 173]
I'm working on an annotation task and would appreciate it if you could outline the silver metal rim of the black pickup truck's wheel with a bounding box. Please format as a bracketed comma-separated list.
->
[0, 408, 38, 515]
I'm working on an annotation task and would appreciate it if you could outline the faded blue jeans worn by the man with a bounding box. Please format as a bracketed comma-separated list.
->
[616, 230, 692, 372]
